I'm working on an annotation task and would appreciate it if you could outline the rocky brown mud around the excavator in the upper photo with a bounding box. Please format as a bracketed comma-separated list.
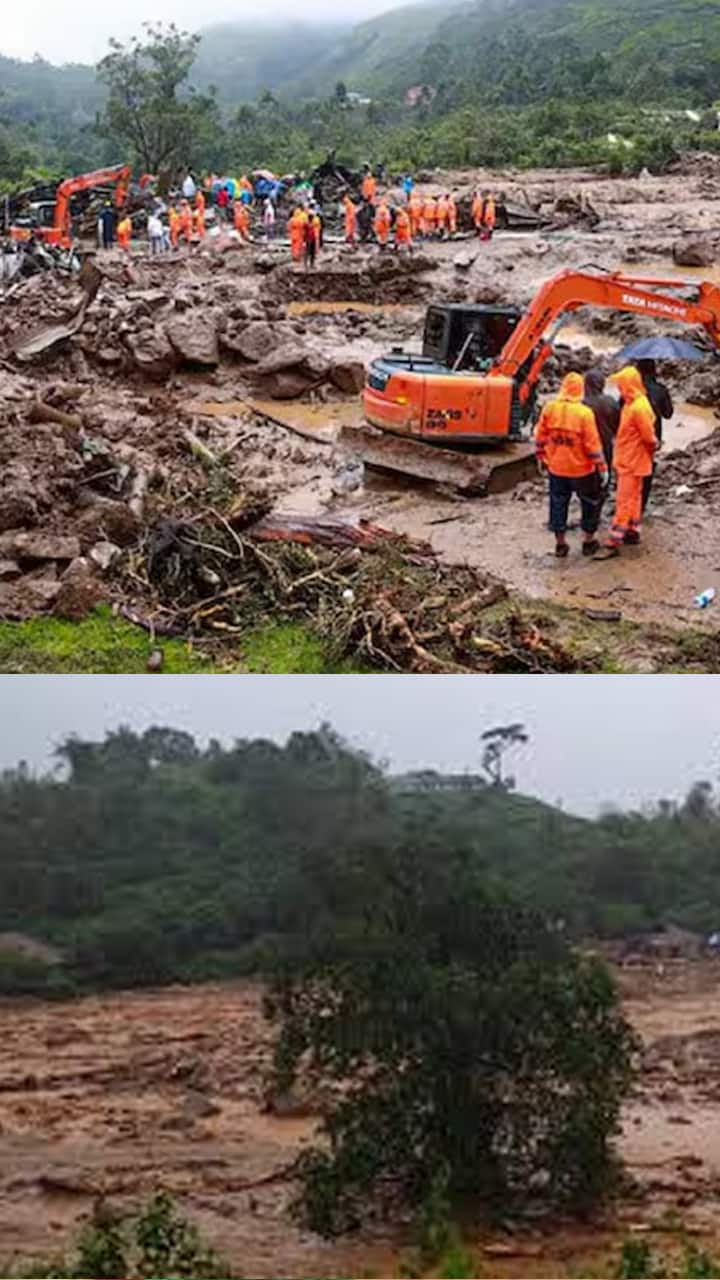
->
[0, 157, 720, 666]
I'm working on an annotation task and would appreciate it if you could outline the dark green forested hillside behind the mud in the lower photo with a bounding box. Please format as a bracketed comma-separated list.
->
[0, 728, 720, 992]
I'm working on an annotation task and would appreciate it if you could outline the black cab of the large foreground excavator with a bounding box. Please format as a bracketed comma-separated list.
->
[423, 302, 523, 371]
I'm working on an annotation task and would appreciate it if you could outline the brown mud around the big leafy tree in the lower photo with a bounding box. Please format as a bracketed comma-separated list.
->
[0, 960, 720, 1277]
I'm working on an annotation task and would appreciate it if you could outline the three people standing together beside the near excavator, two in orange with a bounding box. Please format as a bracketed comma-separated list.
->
[536, 360, 674, 559]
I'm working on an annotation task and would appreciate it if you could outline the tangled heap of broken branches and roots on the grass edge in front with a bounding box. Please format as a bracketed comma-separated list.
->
[120, 511, 577, 672]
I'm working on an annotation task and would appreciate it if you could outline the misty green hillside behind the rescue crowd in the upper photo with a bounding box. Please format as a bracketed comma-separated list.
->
[0, 0, 720, 189]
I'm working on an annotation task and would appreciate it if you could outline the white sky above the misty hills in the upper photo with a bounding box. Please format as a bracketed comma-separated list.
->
[0, 0, 381, 63]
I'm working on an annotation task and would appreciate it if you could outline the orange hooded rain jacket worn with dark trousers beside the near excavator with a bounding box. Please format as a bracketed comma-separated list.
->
[536, 374, 605, 477]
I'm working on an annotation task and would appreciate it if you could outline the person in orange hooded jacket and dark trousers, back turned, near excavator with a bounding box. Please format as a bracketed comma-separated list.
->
[536, 374, 607, 558]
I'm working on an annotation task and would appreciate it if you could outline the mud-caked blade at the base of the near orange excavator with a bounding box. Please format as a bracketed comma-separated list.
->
[338, 426, 537, 498]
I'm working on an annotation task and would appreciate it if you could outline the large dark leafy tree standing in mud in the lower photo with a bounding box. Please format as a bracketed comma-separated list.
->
[268, 840, 634, 1236]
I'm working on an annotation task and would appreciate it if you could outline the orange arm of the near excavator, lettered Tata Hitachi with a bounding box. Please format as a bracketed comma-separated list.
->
[491, 271, 720, 402]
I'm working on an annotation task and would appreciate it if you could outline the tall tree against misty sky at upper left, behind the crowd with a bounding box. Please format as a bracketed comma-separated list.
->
[97, 23, 220, 174]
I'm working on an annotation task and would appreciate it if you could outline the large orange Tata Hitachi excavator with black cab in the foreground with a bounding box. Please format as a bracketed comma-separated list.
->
[342, 270, 720, 493]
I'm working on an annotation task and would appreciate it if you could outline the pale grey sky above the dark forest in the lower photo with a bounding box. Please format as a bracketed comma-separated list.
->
[0, 676, 720, 813]
